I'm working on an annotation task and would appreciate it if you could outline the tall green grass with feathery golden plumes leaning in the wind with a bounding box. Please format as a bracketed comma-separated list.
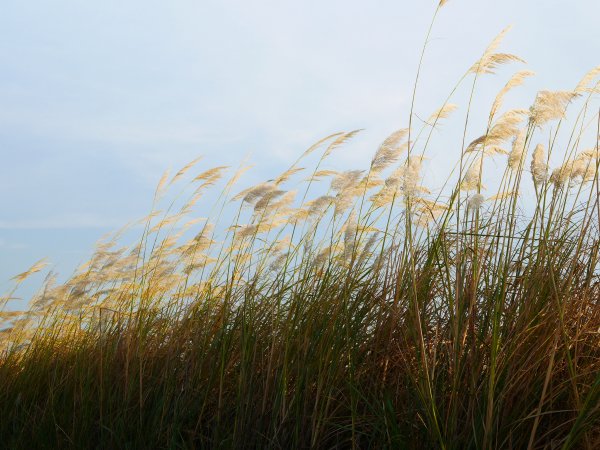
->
[0, 1, 600, 449]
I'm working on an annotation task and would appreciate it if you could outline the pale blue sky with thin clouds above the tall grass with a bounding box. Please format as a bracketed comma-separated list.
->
[0, 0, 600, 302]
